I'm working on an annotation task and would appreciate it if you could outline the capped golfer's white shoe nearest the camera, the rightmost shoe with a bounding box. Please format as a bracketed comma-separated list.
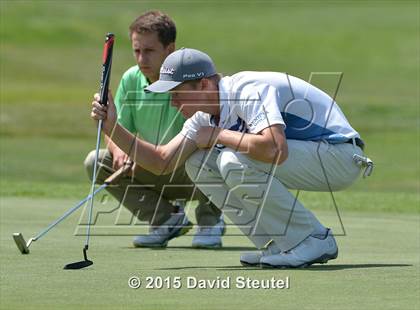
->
[260, 229, 338, 268]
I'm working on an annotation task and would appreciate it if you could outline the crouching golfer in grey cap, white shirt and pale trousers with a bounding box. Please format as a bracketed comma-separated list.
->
[91, 49, 370, 267]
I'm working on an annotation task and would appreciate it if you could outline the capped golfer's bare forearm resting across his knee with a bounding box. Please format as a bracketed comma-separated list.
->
[217, 130, 287, 164]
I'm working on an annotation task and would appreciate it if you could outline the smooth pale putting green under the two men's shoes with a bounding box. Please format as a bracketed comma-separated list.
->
[0, 197, 420, 309]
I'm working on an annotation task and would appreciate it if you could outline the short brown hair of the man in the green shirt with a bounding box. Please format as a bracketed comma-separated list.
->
[129, 11, 176, 46]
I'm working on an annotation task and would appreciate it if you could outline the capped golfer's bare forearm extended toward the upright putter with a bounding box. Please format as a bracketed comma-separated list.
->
[104, 124, 170, 175]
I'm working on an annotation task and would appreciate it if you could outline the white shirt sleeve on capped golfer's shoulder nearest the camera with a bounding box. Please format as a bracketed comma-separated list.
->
[236, 83, 286, 134]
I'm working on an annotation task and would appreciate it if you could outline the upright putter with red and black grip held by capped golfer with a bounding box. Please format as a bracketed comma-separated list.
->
[64, 33, 114, 269]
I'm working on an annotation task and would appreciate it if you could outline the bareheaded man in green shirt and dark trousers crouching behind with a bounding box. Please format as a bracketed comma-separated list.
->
[85, 11, 224, 248]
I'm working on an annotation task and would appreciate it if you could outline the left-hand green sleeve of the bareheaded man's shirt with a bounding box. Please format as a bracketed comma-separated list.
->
[114, 74, 136, 132]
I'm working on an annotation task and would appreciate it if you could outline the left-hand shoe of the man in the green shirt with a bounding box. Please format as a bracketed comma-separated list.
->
[133, 210, 193, 248]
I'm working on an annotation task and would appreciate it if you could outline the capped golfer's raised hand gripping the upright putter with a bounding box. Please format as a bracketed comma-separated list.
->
[90, 91, 117, 135]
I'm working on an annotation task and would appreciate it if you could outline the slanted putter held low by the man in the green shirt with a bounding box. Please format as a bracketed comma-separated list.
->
[13, 162, 133, 254]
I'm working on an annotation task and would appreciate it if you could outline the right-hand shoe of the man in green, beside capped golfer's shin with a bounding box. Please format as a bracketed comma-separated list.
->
[192, 217, 226, 249]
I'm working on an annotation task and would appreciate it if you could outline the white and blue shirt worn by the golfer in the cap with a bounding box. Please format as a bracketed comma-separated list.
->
[181, 71, 360, 143]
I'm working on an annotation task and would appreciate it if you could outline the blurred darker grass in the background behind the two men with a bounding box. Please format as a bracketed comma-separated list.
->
[0, 1, 420, 196]
